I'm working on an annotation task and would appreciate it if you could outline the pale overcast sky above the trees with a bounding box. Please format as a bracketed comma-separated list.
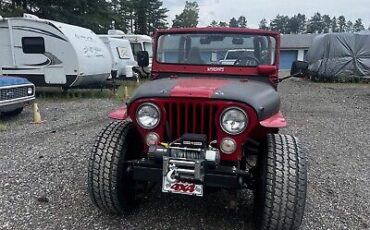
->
[163, 0, 370, 28]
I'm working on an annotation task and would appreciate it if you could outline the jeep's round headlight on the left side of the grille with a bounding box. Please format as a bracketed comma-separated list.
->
[136, 103, 160, 129]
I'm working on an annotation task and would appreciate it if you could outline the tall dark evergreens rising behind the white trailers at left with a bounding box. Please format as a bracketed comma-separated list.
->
[0, 0, 168, 34]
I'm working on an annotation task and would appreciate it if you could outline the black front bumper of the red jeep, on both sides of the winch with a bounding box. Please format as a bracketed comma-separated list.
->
[127, 158, 250, 189]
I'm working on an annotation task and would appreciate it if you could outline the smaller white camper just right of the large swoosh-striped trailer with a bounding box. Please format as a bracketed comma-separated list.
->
[100, 37, 137, 78]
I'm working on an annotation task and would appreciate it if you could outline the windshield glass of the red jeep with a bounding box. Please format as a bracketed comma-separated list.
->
[156, 33, 276, 66]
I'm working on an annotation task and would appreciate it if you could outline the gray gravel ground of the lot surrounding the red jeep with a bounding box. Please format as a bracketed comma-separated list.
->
[0, 79, 370, 229]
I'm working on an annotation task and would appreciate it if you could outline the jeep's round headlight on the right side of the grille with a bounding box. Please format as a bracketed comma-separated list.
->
[220, 107, 248, 135]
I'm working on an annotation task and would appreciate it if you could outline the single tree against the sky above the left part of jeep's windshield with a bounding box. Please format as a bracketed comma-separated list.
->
[172, 1, 199, 27]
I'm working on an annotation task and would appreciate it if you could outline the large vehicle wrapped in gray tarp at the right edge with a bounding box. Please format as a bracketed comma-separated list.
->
[306, 33, 370, 79]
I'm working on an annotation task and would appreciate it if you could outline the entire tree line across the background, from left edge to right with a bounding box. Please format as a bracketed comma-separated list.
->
[0, 0, 370, 34]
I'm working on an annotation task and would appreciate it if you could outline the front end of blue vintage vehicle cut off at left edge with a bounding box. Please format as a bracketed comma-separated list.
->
[0, 76, 35, 115]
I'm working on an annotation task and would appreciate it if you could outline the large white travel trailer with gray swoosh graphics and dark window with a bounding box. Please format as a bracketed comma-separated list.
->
[0, 14, 111, 88]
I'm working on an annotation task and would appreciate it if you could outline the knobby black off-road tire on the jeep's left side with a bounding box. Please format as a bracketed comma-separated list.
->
[87, 120, 144, 215]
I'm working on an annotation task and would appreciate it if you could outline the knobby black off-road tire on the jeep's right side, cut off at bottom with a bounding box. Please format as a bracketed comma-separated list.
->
[255, 134, 307, 230]
